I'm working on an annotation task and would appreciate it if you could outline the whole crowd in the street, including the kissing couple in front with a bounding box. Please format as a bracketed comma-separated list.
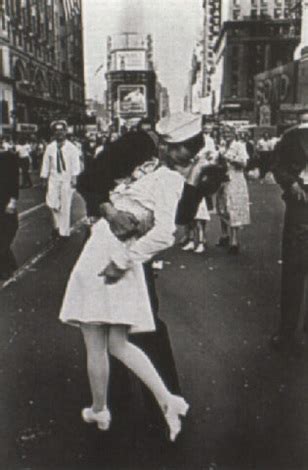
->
[0, 113, 308, 441]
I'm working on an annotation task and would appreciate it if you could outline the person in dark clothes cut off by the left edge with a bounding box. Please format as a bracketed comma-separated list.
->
[0, 138, 19, 280]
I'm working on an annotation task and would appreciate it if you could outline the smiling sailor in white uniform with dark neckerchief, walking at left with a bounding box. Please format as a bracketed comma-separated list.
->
[41, 121, 80, 240]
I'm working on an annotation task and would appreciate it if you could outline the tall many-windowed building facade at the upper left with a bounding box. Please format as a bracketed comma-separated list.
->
[0, 0, 85, 137]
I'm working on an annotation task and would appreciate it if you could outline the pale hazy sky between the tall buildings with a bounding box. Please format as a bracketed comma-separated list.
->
[83, 0, 202, 111]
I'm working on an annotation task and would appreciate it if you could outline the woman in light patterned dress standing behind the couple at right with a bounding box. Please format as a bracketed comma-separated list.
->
[217, 126, 250, 254]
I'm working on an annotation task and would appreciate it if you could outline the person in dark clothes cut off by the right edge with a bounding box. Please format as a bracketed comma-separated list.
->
[271, 110, 308, 349]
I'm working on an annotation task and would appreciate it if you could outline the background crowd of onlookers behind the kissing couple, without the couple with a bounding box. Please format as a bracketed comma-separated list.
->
[0, 119, 286, 288]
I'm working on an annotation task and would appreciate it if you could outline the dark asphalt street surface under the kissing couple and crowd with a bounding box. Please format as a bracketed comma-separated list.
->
[0, 182, 308, 470]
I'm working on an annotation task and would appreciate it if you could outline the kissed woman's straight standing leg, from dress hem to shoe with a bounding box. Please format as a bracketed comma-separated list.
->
[81, 324, 110, 412]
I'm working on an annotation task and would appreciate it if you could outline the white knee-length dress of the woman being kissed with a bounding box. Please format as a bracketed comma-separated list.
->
[60, 167, 184, 333]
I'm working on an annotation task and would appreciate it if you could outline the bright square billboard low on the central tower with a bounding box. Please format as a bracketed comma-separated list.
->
[118, 85, 147, 116]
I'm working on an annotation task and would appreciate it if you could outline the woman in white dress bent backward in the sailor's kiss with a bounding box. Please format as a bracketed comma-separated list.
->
[60, 117, 206, 441]
